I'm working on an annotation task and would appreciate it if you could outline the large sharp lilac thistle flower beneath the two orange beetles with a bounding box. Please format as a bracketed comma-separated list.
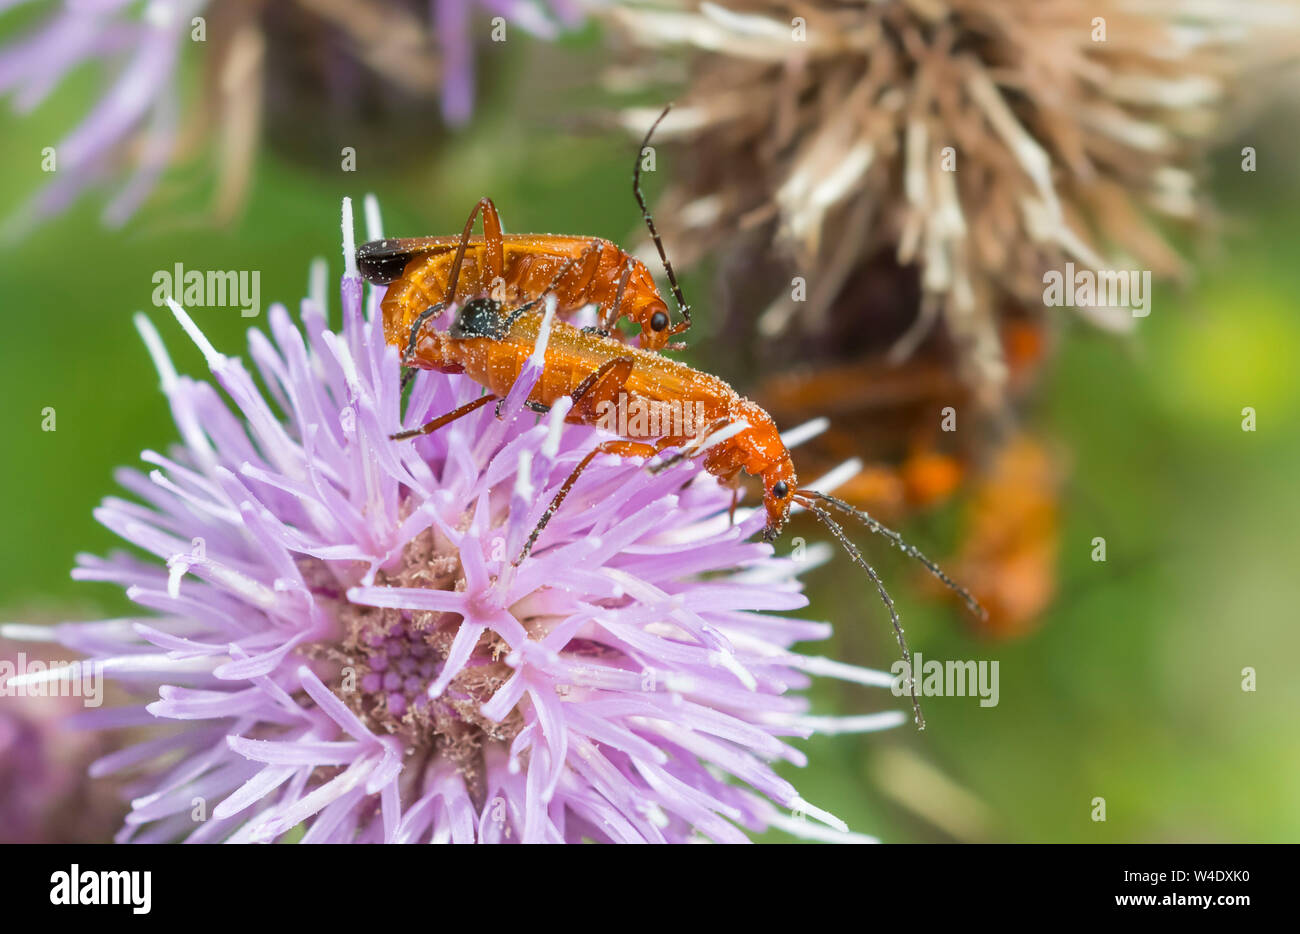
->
[5, 202, 904, 843]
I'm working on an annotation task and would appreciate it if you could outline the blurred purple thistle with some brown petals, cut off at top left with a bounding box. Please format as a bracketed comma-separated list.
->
[0, 0, 590, 234]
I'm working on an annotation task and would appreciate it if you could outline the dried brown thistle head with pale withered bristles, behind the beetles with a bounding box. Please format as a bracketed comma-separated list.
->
[611, 0, 1296, 408]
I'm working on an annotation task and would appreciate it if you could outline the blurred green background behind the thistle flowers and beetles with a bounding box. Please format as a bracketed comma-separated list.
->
[0, 30, 1300, 842]
